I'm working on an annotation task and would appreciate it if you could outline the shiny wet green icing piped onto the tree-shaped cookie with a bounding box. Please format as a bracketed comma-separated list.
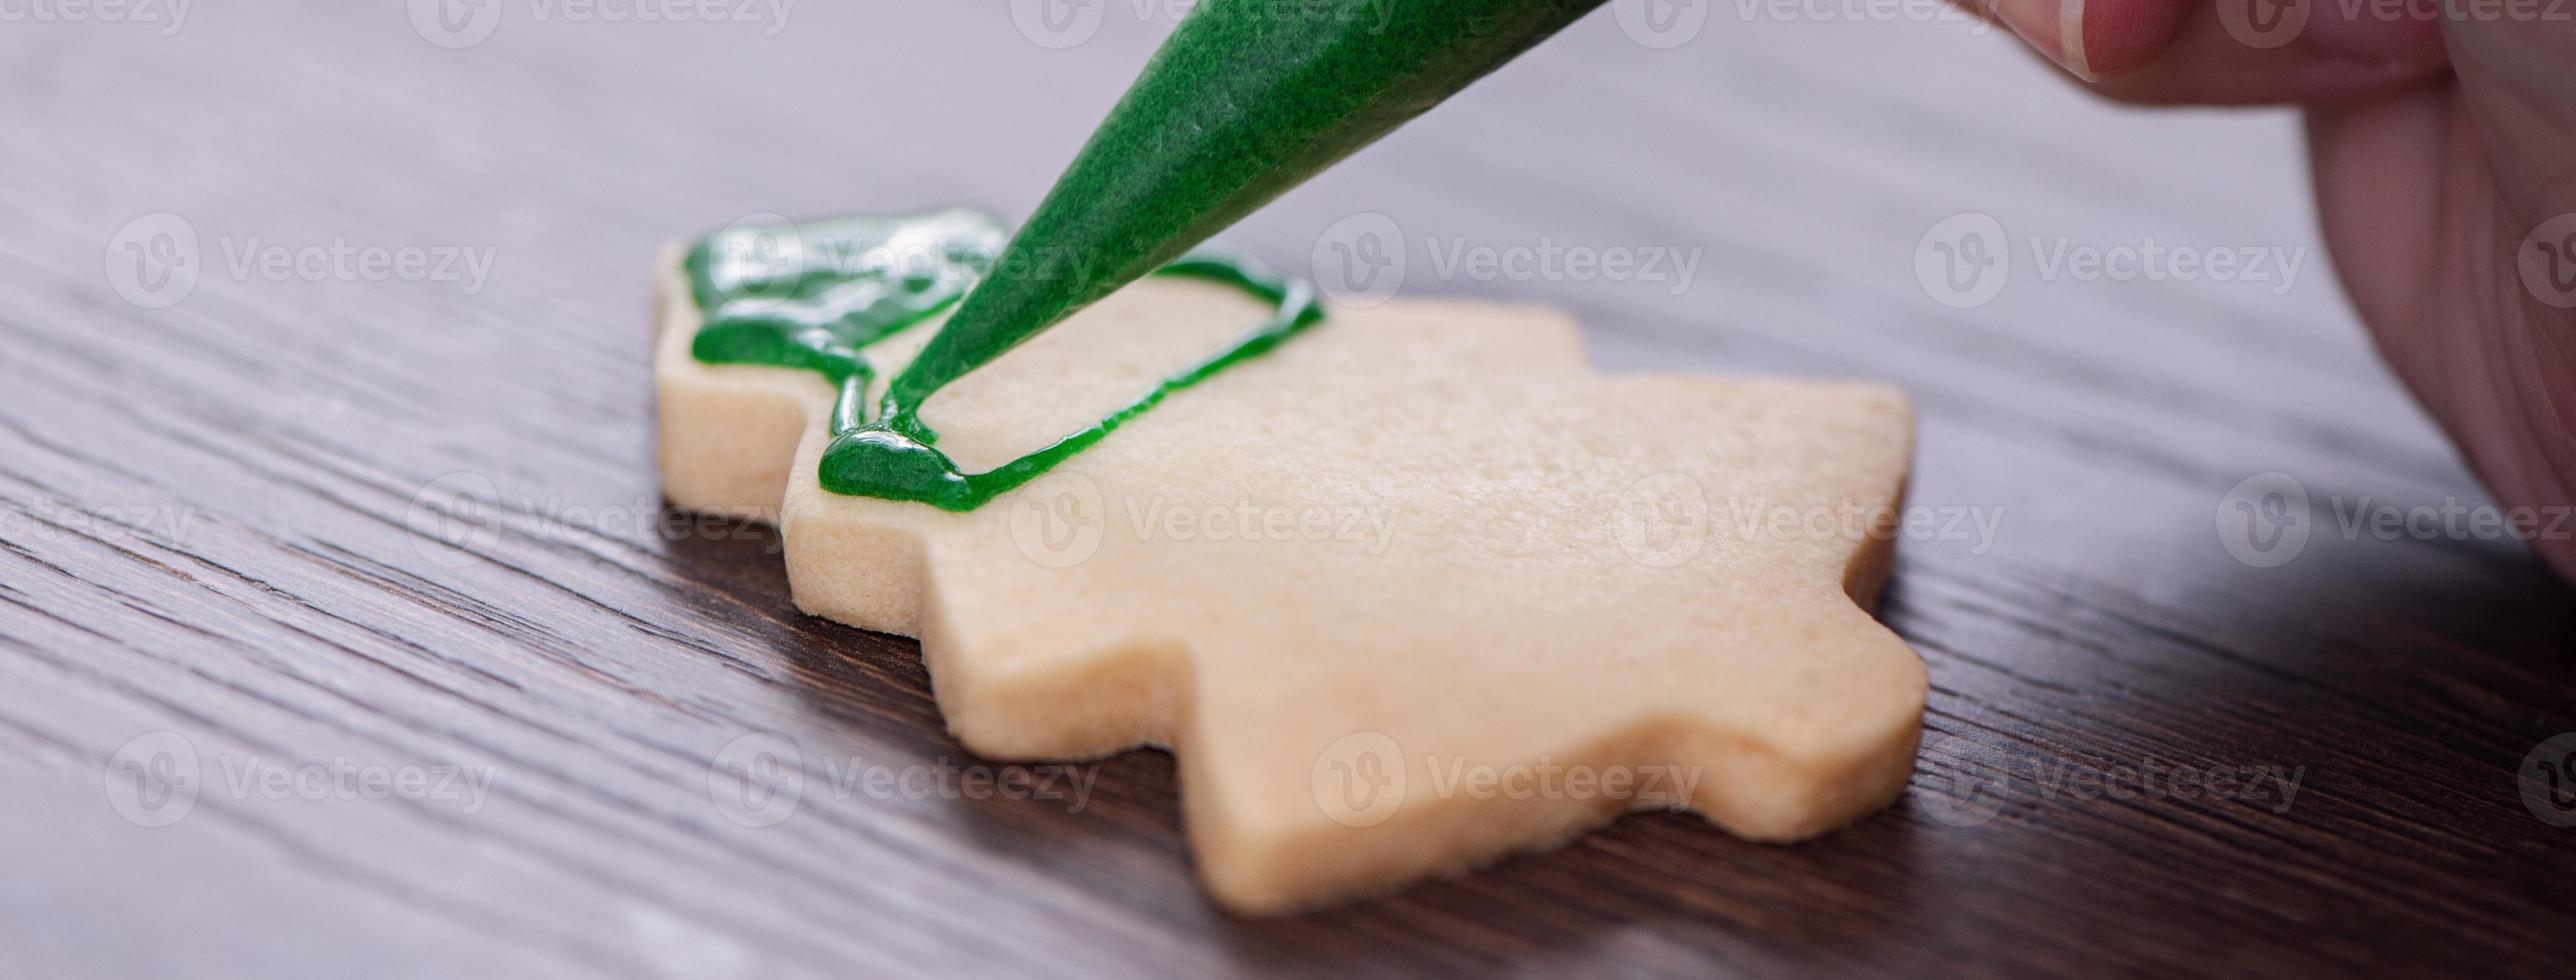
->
[685, 209, 1324, 511]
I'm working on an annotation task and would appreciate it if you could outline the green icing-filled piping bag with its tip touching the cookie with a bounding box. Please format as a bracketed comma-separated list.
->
[886, 0, 1602, 418]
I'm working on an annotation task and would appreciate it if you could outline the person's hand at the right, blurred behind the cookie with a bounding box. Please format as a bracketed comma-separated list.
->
[1994, 0, 2576, 578]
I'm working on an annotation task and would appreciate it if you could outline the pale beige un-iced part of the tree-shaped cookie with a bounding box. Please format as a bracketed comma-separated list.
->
[654, 243, 1924, 913]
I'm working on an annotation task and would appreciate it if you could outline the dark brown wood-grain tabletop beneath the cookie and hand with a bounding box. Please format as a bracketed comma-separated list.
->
[0, 0, 2576, 977]
